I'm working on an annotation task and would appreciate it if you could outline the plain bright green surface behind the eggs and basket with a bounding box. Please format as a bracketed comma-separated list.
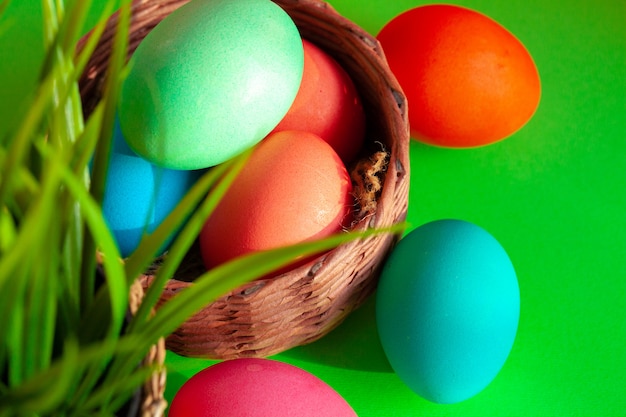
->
[0, 0, 626, 417]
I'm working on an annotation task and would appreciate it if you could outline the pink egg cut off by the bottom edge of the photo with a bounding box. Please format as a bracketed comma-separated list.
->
[168, 358, 356, 417]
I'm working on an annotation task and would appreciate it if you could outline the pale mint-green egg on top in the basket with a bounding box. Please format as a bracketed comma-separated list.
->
[118, 0, 303, 170]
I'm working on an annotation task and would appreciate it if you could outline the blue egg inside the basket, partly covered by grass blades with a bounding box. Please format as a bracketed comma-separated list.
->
[102, 127, 202, 257]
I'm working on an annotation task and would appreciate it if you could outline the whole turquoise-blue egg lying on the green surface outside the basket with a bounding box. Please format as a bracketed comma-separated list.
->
[376, 220, 520, 404]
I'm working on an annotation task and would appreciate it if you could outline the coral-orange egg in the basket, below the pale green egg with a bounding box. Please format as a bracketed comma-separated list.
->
[200, 131, 353, 268]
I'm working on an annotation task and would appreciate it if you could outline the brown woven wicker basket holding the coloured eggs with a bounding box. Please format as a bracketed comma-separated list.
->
[81, 0, 409, 359]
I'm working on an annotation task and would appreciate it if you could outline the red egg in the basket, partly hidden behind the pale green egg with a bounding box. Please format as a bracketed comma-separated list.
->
[274, 40, 365, 163]
